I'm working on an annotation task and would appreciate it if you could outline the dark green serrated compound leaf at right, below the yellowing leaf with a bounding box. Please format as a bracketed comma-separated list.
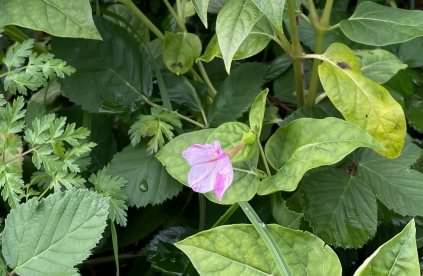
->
[304, 143, 423, 247]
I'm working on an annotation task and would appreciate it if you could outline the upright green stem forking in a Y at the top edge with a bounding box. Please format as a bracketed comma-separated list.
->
[307, 0, 333, 106]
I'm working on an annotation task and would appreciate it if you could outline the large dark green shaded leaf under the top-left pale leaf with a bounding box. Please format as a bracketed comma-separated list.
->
[53, 18, 143, 112]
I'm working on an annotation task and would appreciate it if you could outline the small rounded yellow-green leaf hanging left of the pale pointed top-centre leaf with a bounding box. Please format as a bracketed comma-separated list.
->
[163, 32, 202, 75]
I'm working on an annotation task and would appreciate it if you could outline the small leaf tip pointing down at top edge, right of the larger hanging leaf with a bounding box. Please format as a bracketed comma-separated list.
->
[252, 0, 286, 33]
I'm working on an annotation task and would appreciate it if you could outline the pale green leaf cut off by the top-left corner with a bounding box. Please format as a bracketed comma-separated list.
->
[0, 0, 101, 39]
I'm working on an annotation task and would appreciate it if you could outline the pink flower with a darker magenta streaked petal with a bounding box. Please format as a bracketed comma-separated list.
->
[182, 141, 234, 200]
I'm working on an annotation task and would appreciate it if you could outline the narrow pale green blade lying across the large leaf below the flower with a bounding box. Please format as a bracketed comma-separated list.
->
[239, 202, 292, 276]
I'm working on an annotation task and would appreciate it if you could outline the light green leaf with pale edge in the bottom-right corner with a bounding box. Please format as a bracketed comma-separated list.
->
[354, 219, 421, 276]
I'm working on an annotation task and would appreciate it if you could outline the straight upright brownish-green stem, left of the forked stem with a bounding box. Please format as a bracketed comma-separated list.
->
[288, 0, 304, 106]
